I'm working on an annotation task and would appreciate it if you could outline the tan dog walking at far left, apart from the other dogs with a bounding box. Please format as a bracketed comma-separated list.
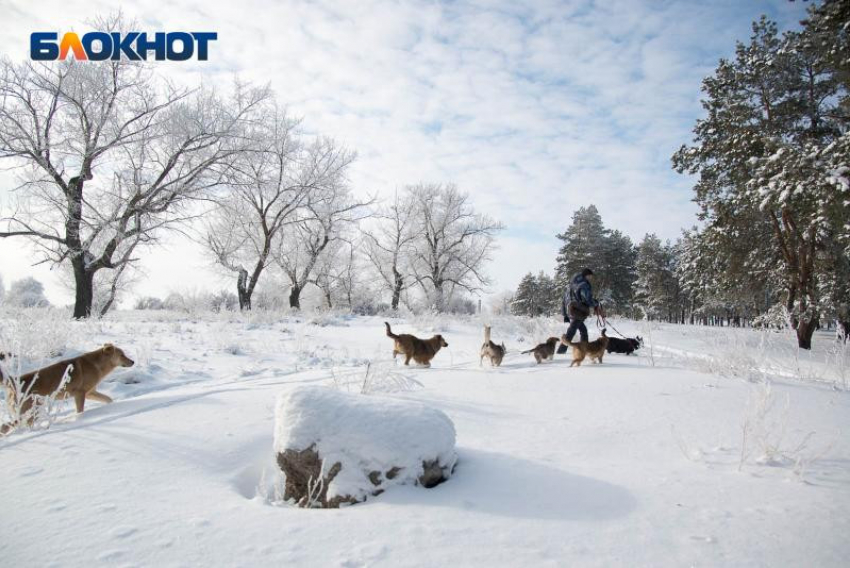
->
[0, 343, 135, 434]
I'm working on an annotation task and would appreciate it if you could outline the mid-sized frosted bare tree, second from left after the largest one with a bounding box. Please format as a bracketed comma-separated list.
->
[206, 108, 354, 310]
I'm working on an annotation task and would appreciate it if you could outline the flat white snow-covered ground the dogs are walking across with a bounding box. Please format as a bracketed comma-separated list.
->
[0, 312, 850, 567]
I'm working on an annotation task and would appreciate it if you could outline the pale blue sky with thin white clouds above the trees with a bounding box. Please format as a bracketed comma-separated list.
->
[0, 0, 805, 303]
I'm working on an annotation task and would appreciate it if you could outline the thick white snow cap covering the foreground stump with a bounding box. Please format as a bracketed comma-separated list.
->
[274, 386, 457, 500]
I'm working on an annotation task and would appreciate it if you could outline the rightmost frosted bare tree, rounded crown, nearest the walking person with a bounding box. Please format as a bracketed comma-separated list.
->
[408, 184, 504, 311]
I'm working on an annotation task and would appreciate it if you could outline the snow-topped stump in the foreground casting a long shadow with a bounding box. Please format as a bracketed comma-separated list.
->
[274, 387, 457, 508]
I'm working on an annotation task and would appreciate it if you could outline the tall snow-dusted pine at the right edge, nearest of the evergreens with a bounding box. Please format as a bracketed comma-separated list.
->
[673, 7, 850, 349]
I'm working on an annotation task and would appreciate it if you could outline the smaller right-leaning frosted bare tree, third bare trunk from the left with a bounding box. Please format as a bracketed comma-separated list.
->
[275, 178, 372, 308]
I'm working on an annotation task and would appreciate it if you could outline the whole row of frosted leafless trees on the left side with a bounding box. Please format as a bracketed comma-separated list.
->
[0, 16, 502, 318]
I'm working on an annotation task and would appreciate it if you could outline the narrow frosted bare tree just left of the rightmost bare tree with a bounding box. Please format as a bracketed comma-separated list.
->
[363, 191, 420, 310]
